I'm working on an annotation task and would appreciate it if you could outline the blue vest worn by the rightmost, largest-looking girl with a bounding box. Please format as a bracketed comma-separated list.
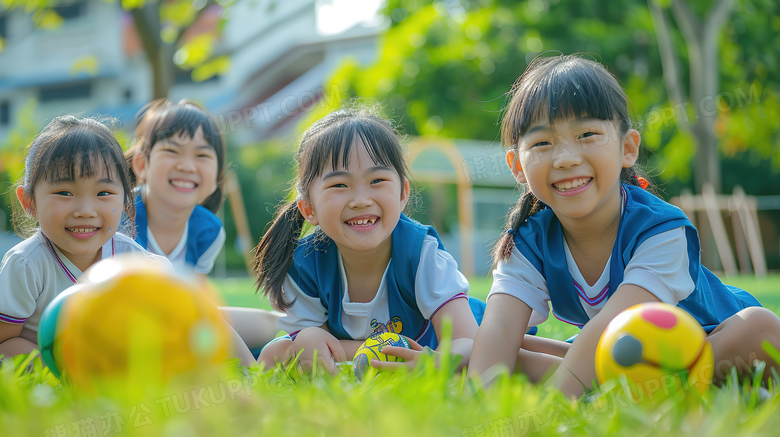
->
[514, 184, 761, 333]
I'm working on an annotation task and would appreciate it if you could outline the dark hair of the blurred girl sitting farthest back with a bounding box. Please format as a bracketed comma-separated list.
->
[125, 99, 225, 214]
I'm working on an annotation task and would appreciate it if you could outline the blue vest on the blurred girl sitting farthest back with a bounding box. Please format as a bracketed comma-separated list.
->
[135, 194, 222, 266]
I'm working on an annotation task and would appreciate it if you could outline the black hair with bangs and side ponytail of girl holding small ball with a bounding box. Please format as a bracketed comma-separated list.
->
[252, 105, 409, 311]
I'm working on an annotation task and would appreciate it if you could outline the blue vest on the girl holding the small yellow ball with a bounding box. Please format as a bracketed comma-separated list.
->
[288, 214, 444, 349]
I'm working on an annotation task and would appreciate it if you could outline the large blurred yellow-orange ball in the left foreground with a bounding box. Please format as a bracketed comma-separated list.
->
[54, 258, 230, 388]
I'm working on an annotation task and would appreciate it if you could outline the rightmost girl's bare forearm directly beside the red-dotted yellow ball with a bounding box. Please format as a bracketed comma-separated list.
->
[548, 284, 659, 397]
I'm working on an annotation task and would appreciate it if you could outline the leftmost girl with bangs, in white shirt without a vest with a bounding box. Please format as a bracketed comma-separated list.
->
[0, 115, 168, 356]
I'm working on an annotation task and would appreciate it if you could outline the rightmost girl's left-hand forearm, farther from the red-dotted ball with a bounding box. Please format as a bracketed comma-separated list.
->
[468, 293, 531, 376]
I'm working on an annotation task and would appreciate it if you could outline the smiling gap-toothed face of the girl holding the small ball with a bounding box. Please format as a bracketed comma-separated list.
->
[298, 142, 409, 253]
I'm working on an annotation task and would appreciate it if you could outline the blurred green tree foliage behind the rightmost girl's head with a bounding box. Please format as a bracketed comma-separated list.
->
[330, 0, 780, 196]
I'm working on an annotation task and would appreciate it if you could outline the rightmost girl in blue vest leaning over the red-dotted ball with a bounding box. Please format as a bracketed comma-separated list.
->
[469, 56, 780, 396]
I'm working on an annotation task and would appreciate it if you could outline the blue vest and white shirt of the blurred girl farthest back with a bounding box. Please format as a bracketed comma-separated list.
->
[134, 188, 225, 275]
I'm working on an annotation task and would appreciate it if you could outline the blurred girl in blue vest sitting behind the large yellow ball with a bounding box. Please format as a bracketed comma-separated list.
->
[125, 99, 280, 358]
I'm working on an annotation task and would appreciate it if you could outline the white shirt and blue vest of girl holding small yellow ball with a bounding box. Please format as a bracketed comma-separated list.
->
[279, 214, 485, 348]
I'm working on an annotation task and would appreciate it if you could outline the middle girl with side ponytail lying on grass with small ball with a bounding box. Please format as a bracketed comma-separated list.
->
[254, 108, 568, 373]
